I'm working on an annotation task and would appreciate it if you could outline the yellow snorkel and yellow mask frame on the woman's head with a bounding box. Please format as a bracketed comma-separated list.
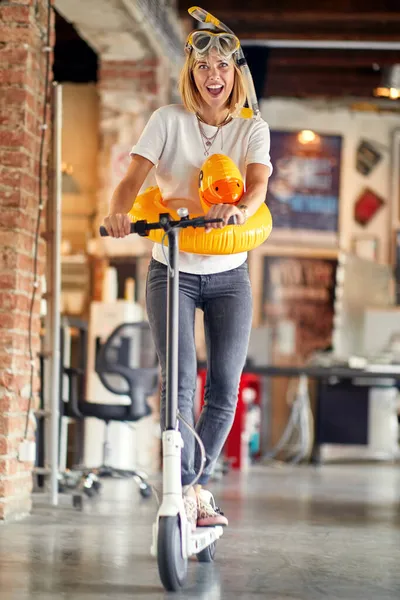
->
[186, 6, 261, 119]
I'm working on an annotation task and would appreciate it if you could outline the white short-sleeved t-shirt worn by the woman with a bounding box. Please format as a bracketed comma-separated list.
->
[130, 104, 272, 274]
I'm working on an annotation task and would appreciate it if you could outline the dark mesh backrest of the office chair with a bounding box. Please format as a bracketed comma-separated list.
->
[96, 321, 159, 420]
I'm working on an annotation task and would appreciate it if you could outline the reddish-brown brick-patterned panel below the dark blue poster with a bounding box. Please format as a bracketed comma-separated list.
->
[262, 256, 337, 360]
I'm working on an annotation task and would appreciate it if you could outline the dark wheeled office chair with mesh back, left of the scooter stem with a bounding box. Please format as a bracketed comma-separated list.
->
[64, 322, 159, 497]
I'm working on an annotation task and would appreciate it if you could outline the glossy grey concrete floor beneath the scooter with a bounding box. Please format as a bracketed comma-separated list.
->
[0, 464, 400, 600]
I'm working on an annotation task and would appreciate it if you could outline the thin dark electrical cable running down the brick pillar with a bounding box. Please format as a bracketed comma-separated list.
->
[24, 0, 52, 440]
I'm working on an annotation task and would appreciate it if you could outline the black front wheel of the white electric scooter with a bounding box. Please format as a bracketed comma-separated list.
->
[157, 515, 187, 592]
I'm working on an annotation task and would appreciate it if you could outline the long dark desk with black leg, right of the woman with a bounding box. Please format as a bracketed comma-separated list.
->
[244, 365, 400, 464]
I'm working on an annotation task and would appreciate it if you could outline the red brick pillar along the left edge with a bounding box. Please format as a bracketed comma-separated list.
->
[0, 0, 54, 519]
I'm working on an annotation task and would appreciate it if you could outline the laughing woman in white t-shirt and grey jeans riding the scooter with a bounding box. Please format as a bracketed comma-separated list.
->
[104, 30, 272, 527]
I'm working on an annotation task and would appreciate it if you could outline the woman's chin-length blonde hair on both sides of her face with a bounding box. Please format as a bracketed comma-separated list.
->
[179, 47, 246, 114]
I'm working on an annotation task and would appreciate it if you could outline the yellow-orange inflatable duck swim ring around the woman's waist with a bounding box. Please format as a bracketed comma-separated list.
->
[129, 154, 272, 254]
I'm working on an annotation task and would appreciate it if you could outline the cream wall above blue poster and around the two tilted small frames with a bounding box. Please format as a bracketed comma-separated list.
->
[261, 98, 400, 262]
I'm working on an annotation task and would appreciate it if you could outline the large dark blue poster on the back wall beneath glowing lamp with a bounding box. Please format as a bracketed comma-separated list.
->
[266, 131, 342, 233]
